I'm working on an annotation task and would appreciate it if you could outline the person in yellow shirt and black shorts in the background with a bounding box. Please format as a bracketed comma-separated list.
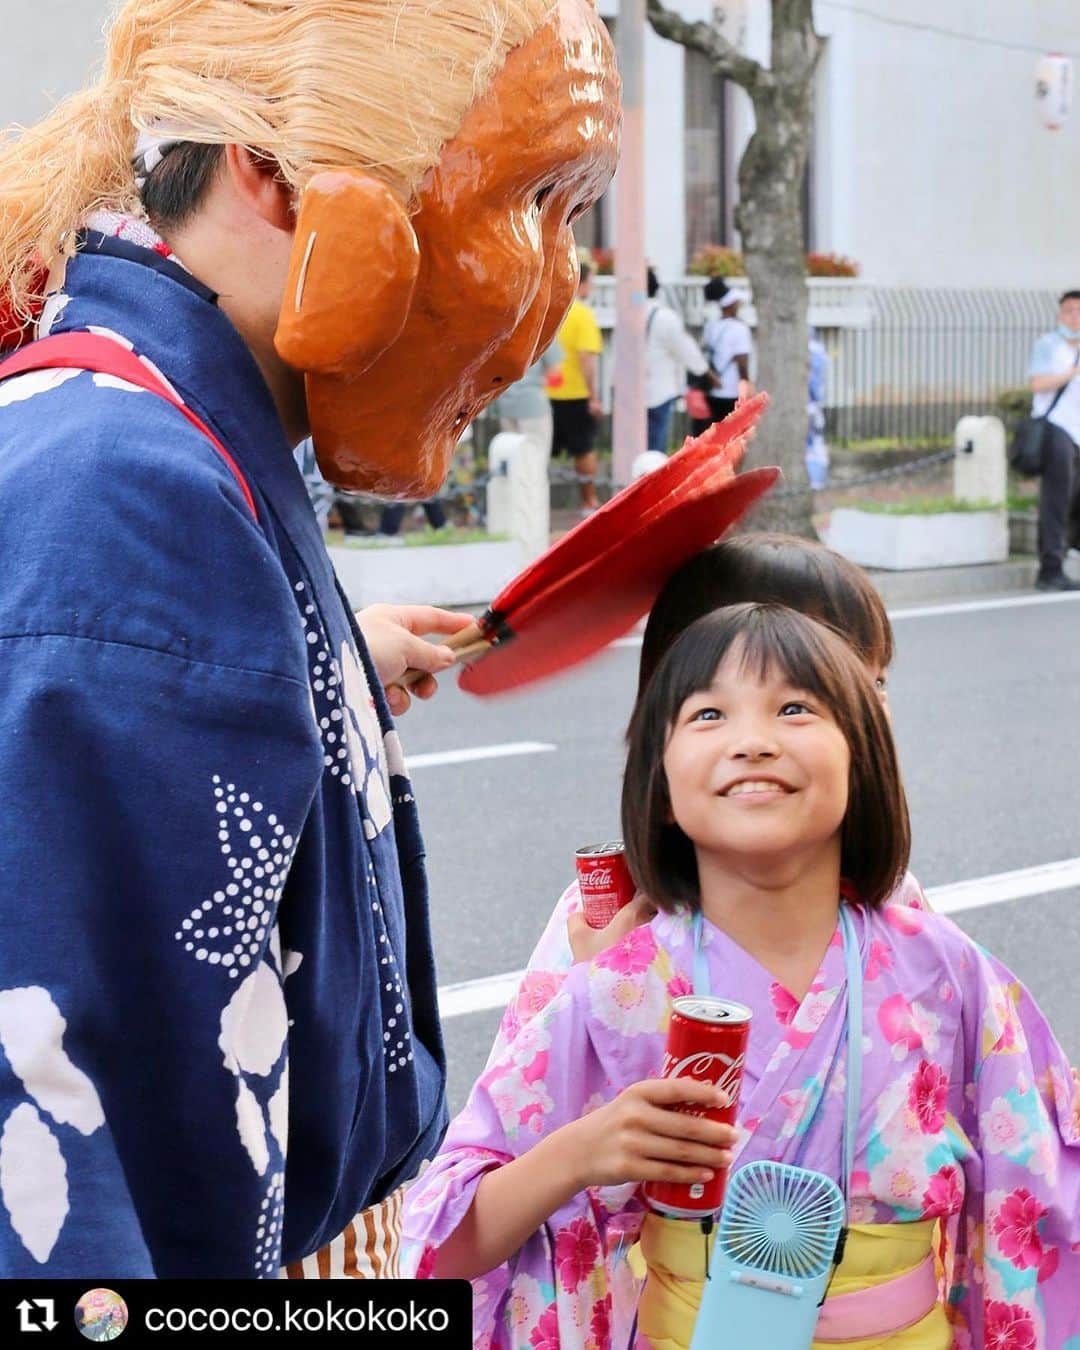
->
[547, 263, 603, 516]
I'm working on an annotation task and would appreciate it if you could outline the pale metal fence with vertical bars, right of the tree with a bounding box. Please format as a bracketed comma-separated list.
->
[822, 288, 1057, 446]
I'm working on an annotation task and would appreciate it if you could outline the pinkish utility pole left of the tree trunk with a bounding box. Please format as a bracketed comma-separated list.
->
[612, 0, 645, 486]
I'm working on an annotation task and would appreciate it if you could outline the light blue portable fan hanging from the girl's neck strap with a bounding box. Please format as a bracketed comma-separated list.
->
[690, 1162, 845, 1350]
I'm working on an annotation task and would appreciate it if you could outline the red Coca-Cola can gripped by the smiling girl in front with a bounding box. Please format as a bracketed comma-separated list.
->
[645, 994, 752, 1219]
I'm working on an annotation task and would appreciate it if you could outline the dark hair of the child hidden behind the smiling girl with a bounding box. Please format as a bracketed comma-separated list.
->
[637, 535, 892, 698]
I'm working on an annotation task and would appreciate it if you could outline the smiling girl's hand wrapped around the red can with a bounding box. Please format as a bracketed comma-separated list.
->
[564, 1079, 738, 1189]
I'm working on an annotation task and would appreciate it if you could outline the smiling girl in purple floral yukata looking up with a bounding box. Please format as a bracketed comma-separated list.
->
[405, 605, 1080, 1350]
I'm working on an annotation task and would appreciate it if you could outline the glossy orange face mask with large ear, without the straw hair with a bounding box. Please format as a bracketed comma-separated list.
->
[275, 0, 620, 498]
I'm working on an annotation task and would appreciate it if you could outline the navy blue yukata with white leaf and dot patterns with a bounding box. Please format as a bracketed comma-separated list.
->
[0, 235, 446, 1278]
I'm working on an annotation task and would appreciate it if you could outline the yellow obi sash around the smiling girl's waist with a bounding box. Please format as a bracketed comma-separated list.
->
[630, 1214, 952, 1350]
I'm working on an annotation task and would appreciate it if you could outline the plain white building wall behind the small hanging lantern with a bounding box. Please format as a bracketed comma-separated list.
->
[810, 0, 1080, 288]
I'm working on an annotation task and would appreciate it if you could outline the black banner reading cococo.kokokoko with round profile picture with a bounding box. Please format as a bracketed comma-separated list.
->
[0, 1278, 473, 1350]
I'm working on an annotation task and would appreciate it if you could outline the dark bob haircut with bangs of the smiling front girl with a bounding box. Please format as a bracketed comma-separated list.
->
[622, 605, 911, 911]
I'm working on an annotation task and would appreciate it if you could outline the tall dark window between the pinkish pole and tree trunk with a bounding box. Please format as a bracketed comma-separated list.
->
[683, 51, 729, 259]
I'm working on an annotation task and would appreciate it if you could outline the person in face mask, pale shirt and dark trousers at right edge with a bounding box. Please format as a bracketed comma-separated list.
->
[1027, 290, 1080, 591]
